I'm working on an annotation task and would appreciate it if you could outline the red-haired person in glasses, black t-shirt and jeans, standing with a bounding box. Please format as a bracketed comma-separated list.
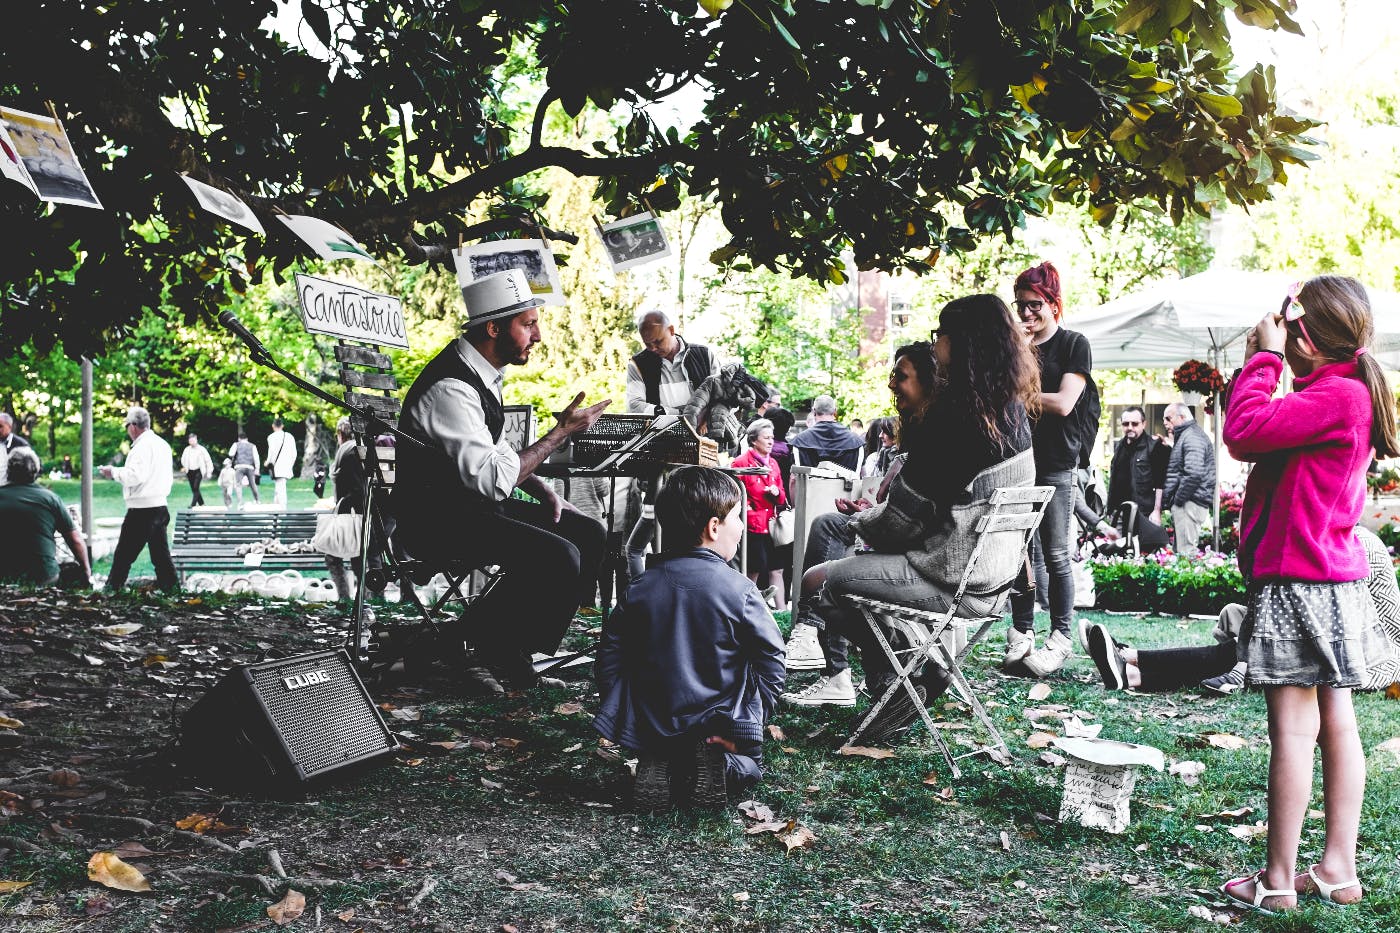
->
[1005, 262, 1093, 677]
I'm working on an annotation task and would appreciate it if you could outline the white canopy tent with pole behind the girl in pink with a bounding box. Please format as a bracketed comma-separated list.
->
[1065, 269, 1400, 546]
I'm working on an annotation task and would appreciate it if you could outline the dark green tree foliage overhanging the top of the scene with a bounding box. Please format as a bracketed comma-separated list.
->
[0, 0, 1312, 354]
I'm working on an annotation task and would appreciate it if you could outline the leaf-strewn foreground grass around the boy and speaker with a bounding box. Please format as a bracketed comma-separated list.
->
[0, 600, 1400, 933]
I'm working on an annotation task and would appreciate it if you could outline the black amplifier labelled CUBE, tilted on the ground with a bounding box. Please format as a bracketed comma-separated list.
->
[179, 650, 399, 792]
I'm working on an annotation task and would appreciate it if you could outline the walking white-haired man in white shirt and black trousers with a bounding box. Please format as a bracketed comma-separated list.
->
[102, 405, 179, 593]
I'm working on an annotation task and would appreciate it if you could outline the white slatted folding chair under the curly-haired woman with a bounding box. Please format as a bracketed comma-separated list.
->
[841, 486, 1054, 778]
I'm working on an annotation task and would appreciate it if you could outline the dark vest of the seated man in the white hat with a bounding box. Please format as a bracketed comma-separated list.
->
[393, 340, 505, 517]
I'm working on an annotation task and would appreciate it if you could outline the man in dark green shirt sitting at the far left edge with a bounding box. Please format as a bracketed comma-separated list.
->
[0, 444, 91, 586]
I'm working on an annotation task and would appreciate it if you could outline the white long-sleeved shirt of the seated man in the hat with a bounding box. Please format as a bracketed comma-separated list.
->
[403, 336, 521, 502]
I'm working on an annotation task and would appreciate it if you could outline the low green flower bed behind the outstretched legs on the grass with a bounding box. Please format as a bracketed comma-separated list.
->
[1089, 551, 1245, 615]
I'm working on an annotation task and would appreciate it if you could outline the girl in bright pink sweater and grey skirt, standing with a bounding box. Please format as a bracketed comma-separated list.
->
[1221, 276, 1400, 912]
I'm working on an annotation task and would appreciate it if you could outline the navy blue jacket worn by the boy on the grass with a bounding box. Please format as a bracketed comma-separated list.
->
[594, 548, 785, 755]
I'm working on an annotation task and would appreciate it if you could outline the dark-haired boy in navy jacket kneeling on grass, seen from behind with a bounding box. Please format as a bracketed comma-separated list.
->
[594, 467, 785, 811]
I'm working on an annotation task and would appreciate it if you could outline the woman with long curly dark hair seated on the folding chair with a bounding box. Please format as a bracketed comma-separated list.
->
[800, 294, 1039, 741]
